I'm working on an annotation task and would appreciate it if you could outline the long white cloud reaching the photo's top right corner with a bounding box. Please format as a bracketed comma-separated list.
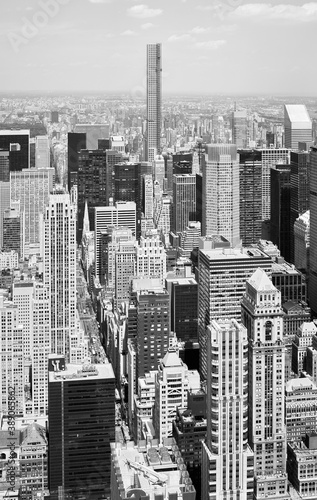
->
[231, 2, 317, 22]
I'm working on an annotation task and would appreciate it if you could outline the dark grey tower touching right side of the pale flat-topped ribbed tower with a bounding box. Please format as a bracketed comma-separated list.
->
[239, 150, 262, 246]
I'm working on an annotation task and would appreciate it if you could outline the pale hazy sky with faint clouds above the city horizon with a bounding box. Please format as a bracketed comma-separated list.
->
[0, 0, 317, 98]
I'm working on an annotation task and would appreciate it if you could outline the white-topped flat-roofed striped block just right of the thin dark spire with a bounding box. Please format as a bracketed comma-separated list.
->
[95, 201, 136, 276]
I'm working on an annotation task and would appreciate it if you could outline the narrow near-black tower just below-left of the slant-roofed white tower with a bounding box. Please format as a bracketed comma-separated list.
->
[270, 165, 291, 262]
